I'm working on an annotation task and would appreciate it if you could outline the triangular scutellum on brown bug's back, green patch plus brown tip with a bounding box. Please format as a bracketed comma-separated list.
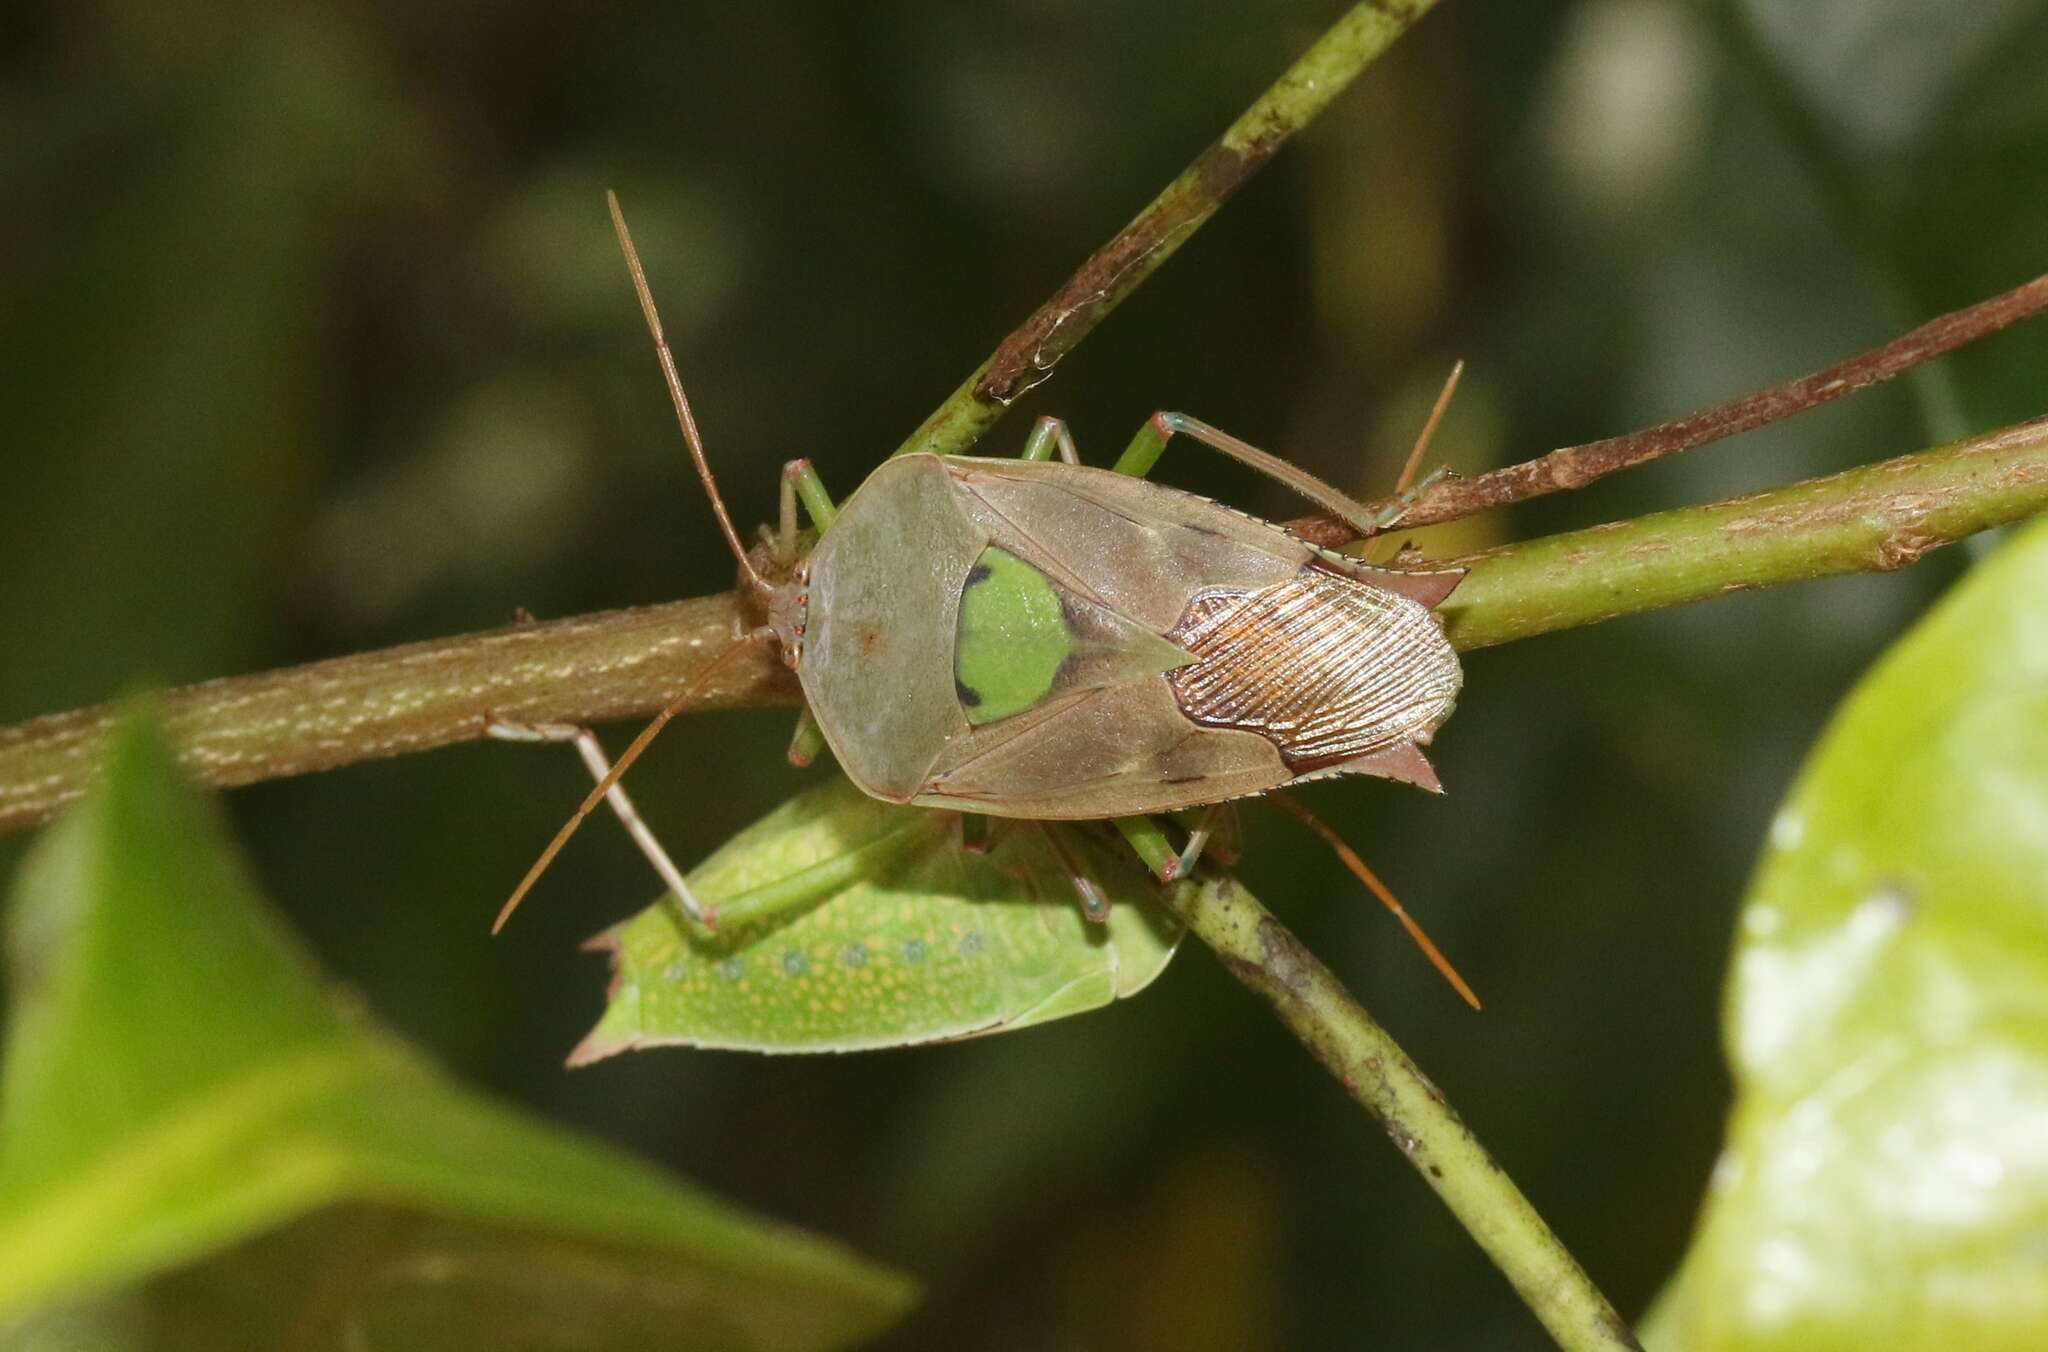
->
[952, 545, 1194, 727]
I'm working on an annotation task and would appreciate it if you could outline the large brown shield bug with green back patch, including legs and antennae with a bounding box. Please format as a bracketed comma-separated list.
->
[494, 197, 1464, 999]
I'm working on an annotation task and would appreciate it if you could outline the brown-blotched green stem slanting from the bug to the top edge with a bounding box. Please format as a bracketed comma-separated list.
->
[895, 0, 1436, 455]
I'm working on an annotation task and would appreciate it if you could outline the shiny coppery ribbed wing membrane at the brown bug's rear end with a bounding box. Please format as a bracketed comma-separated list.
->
[1167, 563, 1462, 774]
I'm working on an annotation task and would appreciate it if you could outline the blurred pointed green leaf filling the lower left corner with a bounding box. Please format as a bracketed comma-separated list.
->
[0, 719, 911, 1350]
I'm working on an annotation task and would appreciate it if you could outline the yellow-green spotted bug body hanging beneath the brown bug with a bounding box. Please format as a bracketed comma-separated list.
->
[571, 776, 1180, 1063]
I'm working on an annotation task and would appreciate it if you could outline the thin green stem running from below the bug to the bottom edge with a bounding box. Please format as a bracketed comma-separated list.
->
[1145, 850, 1638, 1352]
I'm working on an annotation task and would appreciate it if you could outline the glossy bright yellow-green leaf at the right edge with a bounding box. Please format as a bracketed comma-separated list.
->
[1655, 520, 2048, 1352]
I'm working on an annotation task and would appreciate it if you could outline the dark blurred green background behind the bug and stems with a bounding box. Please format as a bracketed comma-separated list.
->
[0, 0, 2048, 1350]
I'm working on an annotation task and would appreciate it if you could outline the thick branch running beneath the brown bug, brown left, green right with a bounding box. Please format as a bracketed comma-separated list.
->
[0, 420, 2048, 832]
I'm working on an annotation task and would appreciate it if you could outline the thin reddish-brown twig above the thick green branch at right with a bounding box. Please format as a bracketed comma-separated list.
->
[1288, 277, 2048, 545]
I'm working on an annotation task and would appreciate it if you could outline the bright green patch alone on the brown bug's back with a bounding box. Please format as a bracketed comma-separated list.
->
[952, 545, 1075, 727]
